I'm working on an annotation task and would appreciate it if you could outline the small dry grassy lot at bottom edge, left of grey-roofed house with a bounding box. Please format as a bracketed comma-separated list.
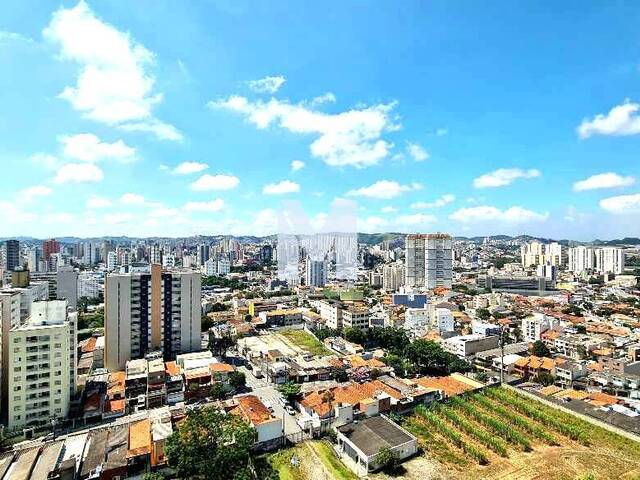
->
[269, 441, 357, 480]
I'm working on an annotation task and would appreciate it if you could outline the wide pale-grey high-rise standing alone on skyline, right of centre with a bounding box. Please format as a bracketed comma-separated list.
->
[405, 233, 453, 288]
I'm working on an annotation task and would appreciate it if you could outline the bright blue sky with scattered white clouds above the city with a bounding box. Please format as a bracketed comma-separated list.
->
[0, 0, 640, 240]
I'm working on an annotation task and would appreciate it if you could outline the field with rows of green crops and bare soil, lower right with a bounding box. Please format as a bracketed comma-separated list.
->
[392, 388, 640, 480]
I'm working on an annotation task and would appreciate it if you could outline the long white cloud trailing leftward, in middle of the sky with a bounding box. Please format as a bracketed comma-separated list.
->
[208, 95, 399, 168]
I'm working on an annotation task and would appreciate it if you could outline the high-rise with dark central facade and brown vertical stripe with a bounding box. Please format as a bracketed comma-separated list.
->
[104, 264, 202, 371]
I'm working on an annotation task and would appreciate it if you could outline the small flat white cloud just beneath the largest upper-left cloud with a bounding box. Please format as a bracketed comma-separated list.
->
[58, 133, 136, 162]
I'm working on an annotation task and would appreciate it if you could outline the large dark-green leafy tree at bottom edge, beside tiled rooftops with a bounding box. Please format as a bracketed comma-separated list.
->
[165, 408, 257, 480]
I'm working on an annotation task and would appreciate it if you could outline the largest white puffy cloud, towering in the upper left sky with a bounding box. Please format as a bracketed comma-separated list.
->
[42, 1, 182, 140]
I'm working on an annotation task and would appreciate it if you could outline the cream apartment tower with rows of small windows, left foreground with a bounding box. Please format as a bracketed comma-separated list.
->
[3, 300, 77, 428]
